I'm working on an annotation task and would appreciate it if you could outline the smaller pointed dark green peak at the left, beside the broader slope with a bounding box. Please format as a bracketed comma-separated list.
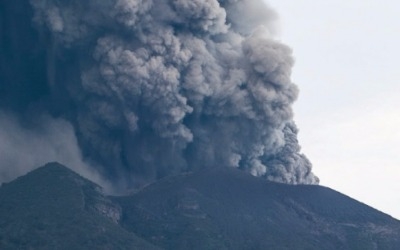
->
[0, 163, 159, 249]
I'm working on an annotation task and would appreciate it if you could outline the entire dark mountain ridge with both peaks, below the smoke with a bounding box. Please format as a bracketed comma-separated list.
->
[0, 163, 400, 250]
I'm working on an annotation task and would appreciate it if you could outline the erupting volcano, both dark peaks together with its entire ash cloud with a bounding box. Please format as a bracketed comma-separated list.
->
[0, 0, 400, 250]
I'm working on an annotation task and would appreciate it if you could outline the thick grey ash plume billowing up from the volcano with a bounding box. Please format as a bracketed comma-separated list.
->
[0, 0, 318, 191]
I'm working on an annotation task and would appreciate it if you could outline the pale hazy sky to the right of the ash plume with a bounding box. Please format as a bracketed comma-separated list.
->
[267, 0, 400, 219]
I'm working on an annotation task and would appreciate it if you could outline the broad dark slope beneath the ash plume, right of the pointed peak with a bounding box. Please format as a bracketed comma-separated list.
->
[115, 168, 400, 250]
